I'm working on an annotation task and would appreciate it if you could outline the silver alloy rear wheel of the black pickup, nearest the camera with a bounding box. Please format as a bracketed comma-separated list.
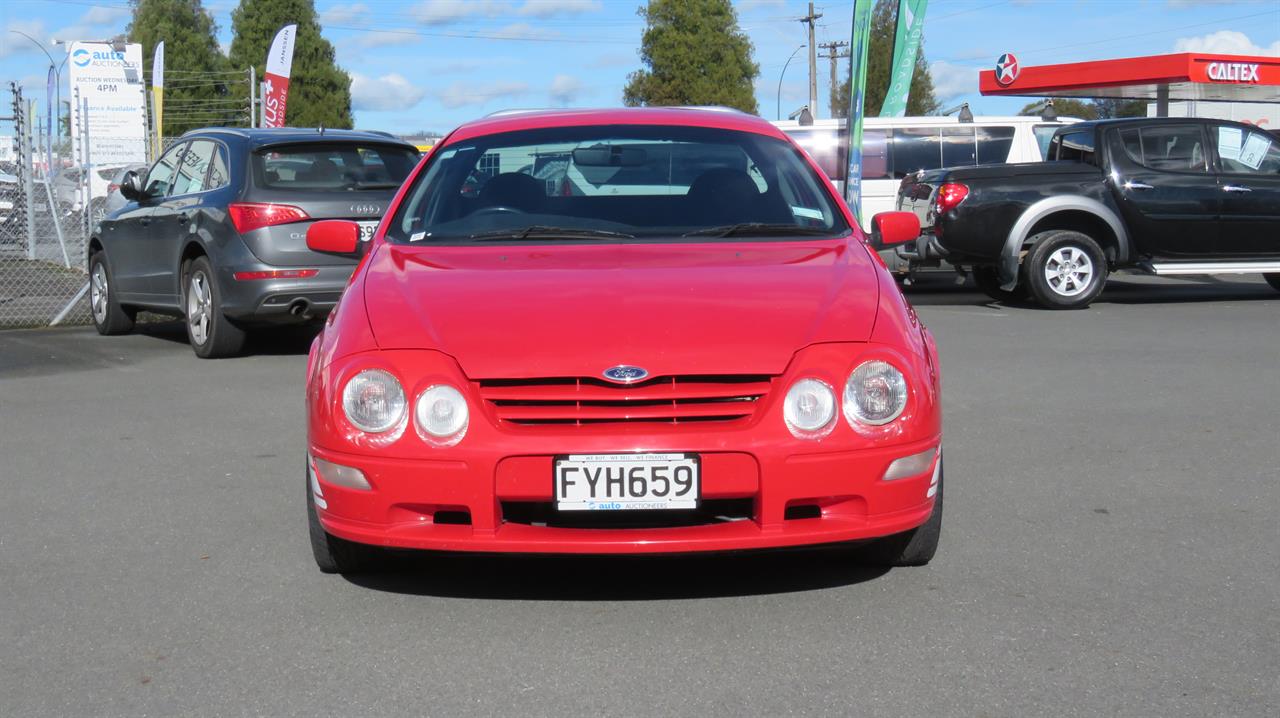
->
[1023, 229, 1107, 310]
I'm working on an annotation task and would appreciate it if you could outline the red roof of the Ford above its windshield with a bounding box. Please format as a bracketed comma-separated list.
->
[442, 108, 786, 145]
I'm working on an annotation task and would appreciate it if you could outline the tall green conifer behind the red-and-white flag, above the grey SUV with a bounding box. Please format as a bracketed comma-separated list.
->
[230, 0, 352, 128]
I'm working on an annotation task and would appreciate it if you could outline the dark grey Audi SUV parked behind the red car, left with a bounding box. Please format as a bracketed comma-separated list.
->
[88, 128, 419, 358]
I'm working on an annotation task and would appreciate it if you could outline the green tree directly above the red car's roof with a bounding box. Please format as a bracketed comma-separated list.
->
[622, 0, 760, 113]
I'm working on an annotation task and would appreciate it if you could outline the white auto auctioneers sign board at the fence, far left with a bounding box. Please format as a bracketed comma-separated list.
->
[68, 42, 147, 166]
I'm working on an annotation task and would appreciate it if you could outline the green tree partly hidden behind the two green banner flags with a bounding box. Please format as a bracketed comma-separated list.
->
[831, 0, 938, 118]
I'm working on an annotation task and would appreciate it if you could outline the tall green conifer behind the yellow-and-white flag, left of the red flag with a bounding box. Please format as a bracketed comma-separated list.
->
[127, 0, 241, 137]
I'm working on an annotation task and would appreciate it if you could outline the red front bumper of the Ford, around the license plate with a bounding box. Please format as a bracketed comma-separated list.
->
[308, 435, 941, 554]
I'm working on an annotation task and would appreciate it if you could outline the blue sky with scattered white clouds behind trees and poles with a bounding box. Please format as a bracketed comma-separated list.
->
[0, 0, 1280, 133]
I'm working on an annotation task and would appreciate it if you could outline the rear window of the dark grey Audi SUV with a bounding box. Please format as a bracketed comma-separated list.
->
[253, 142, 419, 192]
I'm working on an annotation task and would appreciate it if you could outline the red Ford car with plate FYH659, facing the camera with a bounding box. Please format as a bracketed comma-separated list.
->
[306, 109, 942, 572]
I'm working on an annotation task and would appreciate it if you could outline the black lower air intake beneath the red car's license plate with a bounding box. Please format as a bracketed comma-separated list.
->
[502, 498, 755, 529]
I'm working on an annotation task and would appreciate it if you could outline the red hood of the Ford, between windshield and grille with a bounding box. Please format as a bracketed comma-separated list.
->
[362, 239, 878, 379]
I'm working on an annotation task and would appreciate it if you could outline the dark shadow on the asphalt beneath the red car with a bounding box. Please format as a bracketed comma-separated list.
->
[344, 546, 888, 602]
